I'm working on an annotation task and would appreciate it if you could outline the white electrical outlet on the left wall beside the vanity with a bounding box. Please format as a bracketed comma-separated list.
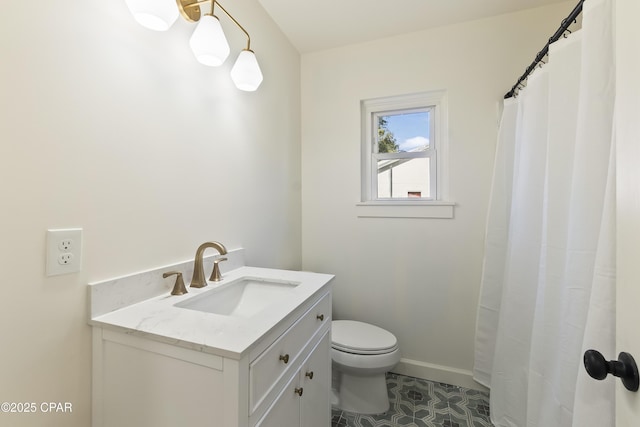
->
[46, 228, 82, 276]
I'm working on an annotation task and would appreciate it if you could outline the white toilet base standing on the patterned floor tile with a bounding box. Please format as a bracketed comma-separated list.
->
[336, 372, 390, 414]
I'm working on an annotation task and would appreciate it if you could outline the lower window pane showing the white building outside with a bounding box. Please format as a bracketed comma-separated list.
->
[378, 157, 431, 199]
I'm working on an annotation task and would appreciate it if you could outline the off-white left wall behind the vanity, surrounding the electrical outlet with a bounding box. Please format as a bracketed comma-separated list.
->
[0, 0, 301, 427]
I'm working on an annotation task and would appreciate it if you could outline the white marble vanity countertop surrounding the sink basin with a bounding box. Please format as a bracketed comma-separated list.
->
[89, 267, 333, 359]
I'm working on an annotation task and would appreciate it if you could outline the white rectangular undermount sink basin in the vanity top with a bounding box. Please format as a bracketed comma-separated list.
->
[175, 277, 299, 317]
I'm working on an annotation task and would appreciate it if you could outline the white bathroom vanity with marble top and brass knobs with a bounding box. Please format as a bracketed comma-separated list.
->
[90, 260, 333, 427]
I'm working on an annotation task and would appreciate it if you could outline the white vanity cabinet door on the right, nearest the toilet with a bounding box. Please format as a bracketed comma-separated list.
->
[300, 331, 331, 427]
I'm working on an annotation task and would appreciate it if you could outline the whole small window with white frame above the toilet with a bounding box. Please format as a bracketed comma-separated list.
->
[359, 91, 453, 218]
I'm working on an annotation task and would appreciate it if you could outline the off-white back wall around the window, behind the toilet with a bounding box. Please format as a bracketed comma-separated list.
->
[302, 2, 574, 386]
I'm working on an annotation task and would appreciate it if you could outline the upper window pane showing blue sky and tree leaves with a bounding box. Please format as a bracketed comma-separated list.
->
[377, 110, 431, 153]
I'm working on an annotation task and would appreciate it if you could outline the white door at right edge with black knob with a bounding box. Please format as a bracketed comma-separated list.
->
[615, 0, 640, 427]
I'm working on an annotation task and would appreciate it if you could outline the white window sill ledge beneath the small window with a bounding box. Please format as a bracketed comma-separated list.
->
[356, 201, 456, 219]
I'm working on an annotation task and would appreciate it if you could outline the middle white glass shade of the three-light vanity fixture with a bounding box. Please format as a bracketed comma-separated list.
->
[189, 15, 229, 67]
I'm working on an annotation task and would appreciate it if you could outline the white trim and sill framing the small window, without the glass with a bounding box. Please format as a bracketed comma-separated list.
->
[356, 90, 455, 218]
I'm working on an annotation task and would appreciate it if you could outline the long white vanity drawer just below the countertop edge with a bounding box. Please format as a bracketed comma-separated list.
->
[249, 294, 331, 414]
